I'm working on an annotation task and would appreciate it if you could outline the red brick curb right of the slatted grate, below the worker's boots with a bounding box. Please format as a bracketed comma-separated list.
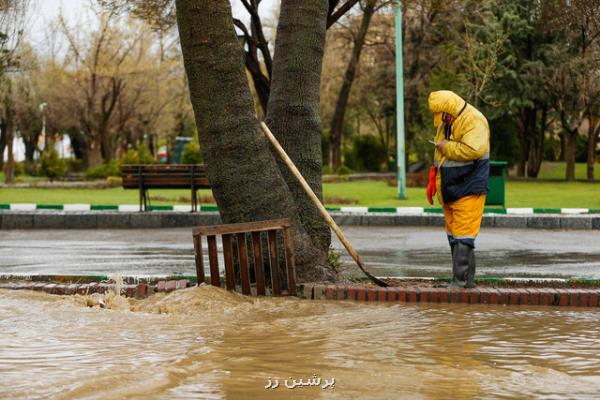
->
[298, 284, 600, 307]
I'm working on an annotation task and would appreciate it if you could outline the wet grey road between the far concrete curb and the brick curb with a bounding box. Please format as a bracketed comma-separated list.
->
[0, 227, 600, 278]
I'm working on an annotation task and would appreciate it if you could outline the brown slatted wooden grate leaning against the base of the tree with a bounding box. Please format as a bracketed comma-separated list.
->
[192, 219, 296, 296]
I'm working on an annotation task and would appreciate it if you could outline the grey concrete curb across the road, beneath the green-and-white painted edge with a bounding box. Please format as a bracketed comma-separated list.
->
[0, 210, 600, 230]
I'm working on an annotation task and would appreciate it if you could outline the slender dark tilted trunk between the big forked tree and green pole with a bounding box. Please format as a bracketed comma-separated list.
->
[329, 0, 376, 171]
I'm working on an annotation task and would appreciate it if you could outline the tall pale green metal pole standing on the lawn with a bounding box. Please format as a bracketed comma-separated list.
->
[395, 0, 408, 199]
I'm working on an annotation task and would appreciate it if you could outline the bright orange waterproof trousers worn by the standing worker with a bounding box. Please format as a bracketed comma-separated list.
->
[444, 194, 485, 247]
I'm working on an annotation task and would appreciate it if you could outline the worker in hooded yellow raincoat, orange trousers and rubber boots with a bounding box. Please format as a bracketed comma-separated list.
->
[427, 90, 490, 287]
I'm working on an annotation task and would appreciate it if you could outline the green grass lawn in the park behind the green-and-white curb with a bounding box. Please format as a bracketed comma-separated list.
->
[0, 181, 600, 208]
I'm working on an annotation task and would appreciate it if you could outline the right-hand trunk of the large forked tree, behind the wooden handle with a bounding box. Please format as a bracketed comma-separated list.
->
[266, 0, 331, 256]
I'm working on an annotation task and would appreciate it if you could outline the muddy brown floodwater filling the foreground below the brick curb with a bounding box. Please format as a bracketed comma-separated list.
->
[0, 287, 600, 399]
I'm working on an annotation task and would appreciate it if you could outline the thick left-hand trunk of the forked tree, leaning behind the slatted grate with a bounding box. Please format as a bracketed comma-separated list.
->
[176, 0, 331, 281]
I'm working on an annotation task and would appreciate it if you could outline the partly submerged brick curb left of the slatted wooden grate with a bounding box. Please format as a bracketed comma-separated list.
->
[0, 279, 190, 299]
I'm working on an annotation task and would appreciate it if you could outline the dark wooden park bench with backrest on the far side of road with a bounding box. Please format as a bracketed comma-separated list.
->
[121, 164, 210, 212]
